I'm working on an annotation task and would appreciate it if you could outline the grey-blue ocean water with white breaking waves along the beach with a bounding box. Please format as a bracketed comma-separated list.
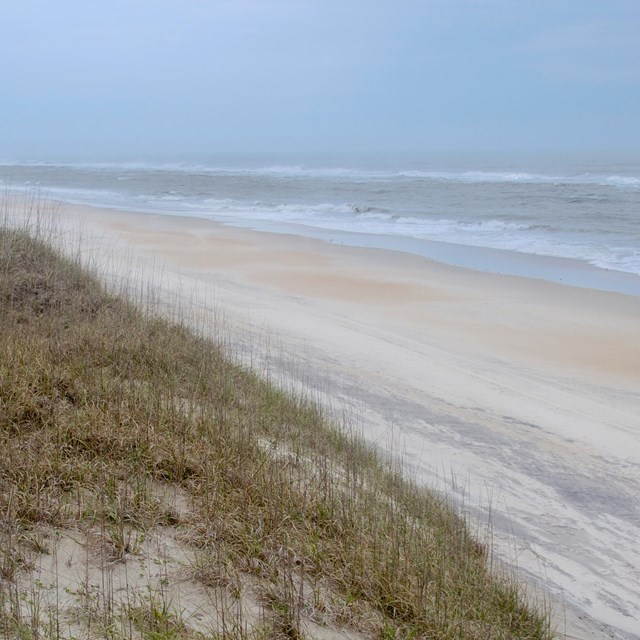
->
[0, 157, 640, 295]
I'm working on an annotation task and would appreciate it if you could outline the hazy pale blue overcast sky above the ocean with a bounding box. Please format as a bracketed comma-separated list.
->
[0, 0, 640, 159]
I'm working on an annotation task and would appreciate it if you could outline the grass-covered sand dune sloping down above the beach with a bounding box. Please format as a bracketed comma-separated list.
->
[0, 202, 553, 640]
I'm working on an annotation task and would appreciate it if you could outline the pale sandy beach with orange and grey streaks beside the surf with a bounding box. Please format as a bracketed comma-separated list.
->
[47, 206, 640, 638]
